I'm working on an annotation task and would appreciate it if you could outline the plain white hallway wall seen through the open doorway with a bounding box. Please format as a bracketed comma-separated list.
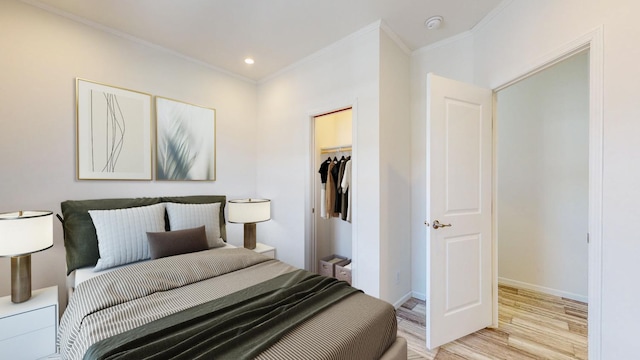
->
[496, 53, 589, 301]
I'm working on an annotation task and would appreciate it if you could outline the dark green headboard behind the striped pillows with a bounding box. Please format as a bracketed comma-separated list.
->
[60, 195, 227, 275]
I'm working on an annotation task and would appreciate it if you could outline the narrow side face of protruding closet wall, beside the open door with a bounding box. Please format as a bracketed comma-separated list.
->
[379, 31, 411, 306]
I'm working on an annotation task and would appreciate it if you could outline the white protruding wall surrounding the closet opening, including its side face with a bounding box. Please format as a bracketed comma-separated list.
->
[257, 24, 410, 303]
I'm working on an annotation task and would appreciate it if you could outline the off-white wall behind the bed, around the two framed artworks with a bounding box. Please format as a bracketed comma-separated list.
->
[0, 0, 262, 310]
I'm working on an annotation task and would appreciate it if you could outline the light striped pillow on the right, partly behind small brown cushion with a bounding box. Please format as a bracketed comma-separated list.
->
[165, 203, 225, 248]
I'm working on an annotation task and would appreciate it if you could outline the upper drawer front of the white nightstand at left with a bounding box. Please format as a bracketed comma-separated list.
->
[0, 305, 57, 340]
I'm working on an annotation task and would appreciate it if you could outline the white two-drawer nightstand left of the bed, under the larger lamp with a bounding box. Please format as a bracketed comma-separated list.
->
[0, 286, 58, 359]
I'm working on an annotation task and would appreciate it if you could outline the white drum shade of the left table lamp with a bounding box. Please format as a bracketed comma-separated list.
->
[0, 211, 53, 256]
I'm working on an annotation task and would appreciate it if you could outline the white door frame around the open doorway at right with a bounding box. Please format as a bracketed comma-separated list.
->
[491, 26, 604, 360]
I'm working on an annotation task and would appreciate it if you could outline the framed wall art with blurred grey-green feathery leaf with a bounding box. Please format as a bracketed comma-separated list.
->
[156, 96, 216, 181]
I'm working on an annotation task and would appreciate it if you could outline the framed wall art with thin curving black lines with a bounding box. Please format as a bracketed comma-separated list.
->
[76, 79, 152, 180]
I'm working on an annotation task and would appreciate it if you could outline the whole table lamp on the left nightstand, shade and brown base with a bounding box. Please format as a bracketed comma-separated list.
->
[0, 211, 53, 303]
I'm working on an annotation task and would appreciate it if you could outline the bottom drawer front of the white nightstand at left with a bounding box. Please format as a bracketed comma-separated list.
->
[0, 324, 56, 360]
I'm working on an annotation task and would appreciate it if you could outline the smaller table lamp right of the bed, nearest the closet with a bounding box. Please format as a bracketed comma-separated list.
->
[228, 199, 271, 249]
